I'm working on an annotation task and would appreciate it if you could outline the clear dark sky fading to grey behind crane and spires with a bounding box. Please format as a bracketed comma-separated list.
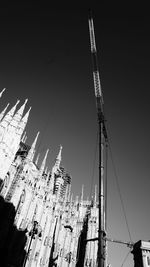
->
[0, 6, 150, 267]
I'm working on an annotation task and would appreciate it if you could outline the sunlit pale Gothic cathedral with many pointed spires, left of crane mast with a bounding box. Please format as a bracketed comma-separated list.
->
[0, 89, 98, 267]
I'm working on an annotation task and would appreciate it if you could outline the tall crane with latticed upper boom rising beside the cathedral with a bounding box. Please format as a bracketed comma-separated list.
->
[89, 12, 107, 267]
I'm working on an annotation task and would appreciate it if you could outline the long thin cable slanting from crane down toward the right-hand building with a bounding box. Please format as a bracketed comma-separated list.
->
[107, 124, 133, 243]
